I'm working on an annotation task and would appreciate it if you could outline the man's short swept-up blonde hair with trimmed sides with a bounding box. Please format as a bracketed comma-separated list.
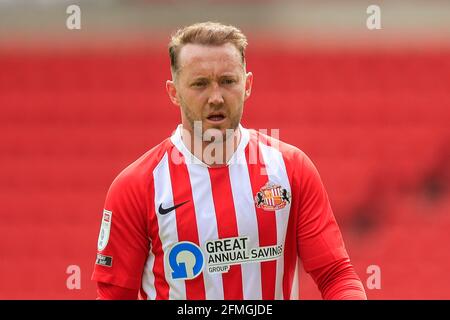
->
[169, 21, 247, 75]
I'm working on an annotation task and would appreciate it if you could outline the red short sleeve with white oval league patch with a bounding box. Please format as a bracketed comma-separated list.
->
[92, 170, 150, 289]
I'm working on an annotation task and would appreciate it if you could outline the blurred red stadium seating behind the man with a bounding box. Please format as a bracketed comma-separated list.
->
[0, 46, 450, 299]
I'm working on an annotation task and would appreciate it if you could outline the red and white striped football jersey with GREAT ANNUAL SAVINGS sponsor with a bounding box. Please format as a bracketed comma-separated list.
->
[92, 125, 348, 300]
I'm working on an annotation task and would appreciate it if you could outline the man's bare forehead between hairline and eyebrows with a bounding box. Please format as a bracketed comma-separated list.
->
[178, 43, 242, 75]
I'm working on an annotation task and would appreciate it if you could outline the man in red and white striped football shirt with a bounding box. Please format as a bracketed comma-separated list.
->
[93, 22, 366, 299]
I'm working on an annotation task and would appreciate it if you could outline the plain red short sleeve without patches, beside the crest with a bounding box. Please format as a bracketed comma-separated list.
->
[294, 152, 348, 272]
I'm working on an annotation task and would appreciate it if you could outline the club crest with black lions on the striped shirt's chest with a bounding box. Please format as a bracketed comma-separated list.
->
[255, 182, 291, 211]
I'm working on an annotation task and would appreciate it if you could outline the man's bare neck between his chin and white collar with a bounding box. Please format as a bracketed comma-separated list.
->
[181, 127, 241, 167]
